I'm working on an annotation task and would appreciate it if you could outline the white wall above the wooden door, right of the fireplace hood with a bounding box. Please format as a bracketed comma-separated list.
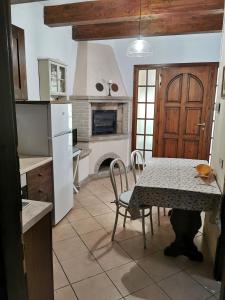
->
[96, 33, 221, 96]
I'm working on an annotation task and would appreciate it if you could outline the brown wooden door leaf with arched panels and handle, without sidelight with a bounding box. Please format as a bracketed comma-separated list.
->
[156, 64, 218, 160]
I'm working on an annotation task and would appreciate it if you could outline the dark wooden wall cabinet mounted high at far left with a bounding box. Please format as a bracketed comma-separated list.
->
[12, 25, 27, 100]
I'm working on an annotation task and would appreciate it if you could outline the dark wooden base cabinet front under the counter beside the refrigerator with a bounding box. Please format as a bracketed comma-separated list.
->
[27, 162, 53, 202]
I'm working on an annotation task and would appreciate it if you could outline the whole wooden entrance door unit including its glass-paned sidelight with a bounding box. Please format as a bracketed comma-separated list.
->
[132, 63, 218, 160]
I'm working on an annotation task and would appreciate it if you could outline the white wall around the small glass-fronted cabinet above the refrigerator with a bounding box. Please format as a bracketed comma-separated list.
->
[11, 3, 77, 100]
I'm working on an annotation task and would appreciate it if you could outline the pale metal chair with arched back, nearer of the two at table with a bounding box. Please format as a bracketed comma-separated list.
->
[110, 158, 153, 249]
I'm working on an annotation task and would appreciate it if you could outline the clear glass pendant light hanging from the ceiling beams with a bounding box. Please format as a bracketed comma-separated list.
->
[127, 0, 152, 57]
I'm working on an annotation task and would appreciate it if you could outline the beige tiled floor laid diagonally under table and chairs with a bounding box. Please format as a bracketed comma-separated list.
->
[53, 174, 220, 300]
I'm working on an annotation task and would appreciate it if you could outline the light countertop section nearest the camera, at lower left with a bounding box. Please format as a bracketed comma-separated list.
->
[22, 200, 53, 233]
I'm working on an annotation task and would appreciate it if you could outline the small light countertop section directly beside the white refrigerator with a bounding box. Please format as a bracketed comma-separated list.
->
[20, 156, 52, 175]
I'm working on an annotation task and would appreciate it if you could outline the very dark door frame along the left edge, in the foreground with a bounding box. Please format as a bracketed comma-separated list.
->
[0, 0, 27, 300]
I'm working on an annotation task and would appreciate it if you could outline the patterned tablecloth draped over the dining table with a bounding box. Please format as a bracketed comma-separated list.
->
[129, 158, 221, 219]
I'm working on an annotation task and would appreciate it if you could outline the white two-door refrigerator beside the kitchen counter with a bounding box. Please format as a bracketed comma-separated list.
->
[16, 101, 73, 224]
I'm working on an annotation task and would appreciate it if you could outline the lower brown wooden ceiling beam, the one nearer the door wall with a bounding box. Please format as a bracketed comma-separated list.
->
[73, 13, 223, 41]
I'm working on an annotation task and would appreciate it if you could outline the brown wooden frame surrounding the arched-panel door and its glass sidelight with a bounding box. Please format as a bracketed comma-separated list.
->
[131, 62, 219, 156]
